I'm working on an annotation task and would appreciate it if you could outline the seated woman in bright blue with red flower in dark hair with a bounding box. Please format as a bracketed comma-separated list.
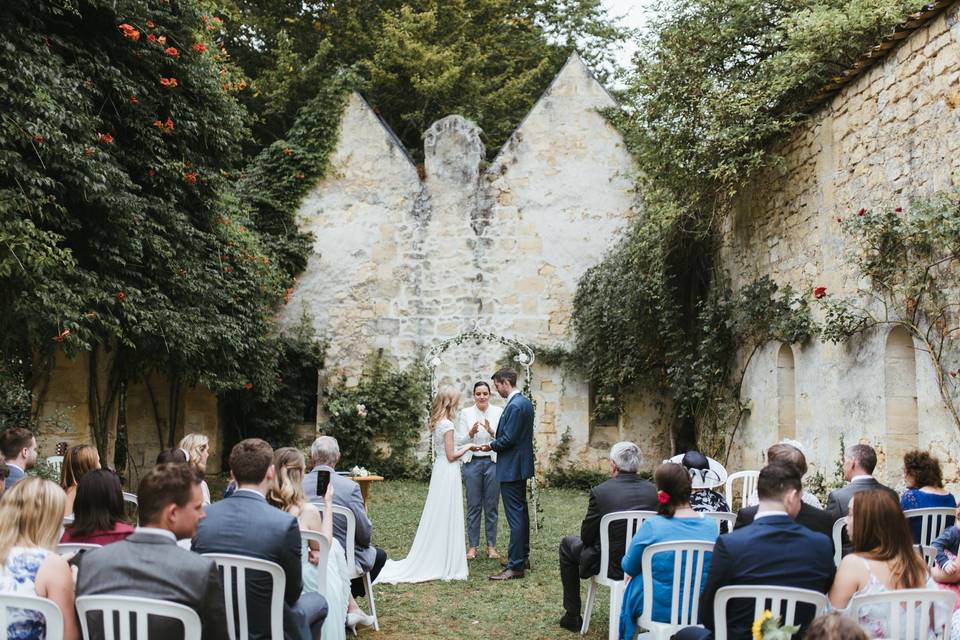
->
[620, 462, 720, 640]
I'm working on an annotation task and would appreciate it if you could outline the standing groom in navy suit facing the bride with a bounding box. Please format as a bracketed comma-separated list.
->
[483, 368, 533, 580]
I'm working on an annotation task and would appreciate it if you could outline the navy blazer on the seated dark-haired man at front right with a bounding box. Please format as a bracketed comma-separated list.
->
[700, 515, 836, 638]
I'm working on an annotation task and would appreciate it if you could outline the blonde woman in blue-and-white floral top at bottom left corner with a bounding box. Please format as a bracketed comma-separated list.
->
[0, 478, 80, 640]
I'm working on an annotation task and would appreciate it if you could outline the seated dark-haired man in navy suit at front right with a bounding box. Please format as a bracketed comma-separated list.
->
[676, 462, 834, 640]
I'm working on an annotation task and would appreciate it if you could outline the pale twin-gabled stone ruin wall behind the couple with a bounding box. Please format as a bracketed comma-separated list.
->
[281, 55, 664, 468]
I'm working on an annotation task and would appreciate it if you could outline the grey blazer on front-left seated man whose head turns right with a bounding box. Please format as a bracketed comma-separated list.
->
[77, 532, 227, 640]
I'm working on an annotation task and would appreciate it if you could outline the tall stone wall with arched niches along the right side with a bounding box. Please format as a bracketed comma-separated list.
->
[723, 5, 960, 482]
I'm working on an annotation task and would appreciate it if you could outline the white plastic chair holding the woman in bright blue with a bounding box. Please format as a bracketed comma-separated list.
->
[635, 540, 713, 640]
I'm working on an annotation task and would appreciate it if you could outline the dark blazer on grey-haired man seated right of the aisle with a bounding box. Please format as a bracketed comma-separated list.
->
[580, 472, 657, 580]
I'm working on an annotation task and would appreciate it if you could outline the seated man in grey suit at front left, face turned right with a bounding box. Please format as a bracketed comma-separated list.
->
[77, 464, 227, 640]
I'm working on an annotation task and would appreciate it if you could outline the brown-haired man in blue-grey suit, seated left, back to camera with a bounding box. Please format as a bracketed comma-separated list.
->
[193, 438, 327, 640]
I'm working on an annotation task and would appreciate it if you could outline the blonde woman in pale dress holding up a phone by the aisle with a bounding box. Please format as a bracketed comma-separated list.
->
[267, 447, 362, 640]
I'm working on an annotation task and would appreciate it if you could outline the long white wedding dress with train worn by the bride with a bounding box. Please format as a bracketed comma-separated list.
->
[377, 420, 467, 584]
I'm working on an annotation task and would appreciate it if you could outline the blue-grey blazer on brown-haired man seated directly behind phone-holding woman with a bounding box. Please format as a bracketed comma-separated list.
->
[193, 489, 303, 640]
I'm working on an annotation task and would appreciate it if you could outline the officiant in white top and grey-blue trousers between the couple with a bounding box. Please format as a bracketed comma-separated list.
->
[457, 381, 503, 560]
